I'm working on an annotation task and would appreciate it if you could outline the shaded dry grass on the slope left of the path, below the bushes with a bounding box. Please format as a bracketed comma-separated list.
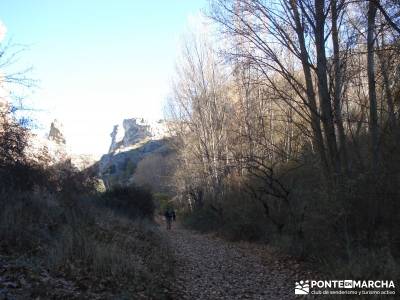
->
[0, 192, 173, 299]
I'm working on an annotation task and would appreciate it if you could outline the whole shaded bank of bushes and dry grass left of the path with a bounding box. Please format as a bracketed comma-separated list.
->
[0, 113, 173, 299]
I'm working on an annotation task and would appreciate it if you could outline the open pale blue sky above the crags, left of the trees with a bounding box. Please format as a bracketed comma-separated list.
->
[0, 0, 207, 155]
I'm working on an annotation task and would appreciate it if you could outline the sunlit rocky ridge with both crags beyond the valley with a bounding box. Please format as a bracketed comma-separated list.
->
[28, 118, 173, 188]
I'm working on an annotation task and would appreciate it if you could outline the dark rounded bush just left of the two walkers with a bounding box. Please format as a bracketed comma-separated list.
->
[101, 186, 155, 219]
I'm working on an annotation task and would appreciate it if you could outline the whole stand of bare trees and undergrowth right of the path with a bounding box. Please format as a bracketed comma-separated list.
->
[170, 0, 400, 278]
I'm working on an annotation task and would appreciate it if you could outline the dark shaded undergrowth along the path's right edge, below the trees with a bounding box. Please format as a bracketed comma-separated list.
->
[183, 149, 400, 278]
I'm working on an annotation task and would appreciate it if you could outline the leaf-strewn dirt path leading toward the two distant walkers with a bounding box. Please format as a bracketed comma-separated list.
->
[164, 224, 308, 300]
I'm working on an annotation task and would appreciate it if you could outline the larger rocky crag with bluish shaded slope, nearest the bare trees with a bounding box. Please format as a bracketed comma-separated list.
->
[98, 118, 171, 188]
